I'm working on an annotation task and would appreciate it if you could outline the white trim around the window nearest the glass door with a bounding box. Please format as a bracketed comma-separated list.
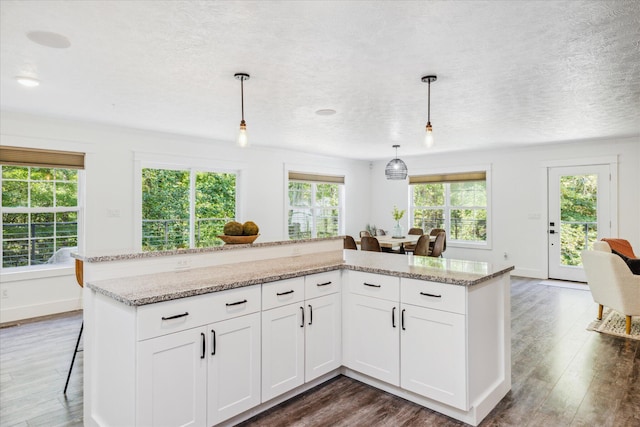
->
[407, 164, 493, 250]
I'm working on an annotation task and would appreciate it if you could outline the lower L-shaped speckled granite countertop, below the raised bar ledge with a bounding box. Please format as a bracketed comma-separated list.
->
[86, 250, 514, 306]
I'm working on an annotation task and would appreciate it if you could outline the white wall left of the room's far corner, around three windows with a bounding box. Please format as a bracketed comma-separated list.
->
[0, 112, 370, 322]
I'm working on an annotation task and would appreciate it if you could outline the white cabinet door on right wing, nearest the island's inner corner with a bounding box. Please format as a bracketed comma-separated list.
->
[343, 294, 400, 386]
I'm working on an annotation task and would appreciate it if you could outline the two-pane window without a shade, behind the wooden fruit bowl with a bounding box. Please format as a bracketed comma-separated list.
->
[142, 168, 236, 251]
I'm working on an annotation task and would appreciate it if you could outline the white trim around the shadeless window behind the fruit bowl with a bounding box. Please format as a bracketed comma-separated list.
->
[132, 151, 249, 251]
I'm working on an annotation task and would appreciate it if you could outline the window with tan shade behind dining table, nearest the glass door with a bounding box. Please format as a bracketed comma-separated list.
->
[409, 172, 488, 243]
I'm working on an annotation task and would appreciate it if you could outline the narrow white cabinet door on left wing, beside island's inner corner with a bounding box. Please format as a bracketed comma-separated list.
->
[304, 294, 342, 382]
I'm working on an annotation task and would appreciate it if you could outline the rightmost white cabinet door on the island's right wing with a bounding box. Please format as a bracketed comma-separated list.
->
[400, 305, 469, 411]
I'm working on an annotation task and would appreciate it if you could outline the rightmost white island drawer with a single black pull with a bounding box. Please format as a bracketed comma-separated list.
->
[400, 278, 467, 314]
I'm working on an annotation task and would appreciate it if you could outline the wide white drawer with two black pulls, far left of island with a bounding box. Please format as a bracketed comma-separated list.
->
[137, 285, 261, 340]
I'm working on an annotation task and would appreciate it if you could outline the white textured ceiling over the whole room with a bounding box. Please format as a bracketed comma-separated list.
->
[0, 0, 640, 159]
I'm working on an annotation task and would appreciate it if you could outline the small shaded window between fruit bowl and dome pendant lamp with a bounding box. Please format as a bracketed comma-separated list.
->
[287, 172, 344, 240]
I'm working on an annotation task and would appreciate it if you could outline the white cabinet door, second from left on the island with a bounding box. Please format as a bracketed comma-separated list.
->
[207, 313, 261, 426]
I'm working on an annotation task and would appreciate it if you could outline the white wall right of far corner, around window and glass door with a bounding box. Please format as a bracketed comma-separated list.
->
[371, 138, 640, 278]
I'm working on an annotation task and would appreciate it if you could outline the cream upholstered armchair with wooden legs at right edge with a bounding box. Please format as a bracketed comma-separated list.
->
[581, 242, 640, 334]
